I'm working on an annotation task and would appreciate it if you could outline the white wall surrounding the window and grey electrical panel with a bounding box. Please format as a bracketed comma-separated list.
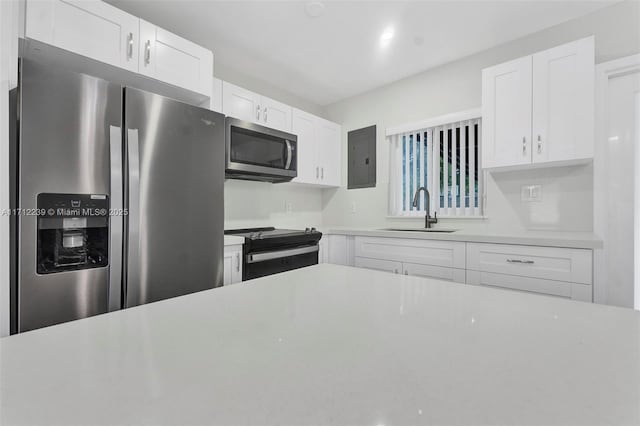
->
[323, 1, 640, 232]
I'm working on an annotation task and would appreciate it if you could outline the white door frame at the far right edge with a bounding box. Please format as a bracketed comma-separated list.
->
[593, 54, 640, 308]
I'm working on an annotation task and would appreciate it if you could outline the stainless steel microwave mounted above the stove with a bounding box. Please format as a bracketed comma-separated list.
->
[225, 117, 298, 183]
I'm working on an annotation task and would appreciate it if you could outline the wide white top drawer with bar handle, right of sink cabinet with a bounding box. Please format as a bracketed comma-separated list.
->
[467, 243, 592, 285]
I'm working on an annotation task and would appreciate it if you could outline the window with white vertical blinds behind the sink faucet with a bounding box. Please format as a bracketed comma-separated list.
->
[387, 118, 482, 217]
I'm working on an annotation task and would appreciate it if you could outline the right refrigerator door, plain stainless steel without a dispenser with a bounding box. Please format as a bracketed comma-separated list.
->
[124, 88, 224, 307]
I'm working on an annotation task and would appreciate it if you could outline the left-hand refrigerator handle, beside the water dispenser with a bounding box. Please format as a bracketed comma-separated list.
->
[109, 126, 124, 311]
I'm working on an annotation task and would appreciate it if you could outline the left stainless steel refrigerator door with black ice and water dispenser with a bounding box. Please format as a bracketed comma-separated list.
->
[15, 59, 122, 331]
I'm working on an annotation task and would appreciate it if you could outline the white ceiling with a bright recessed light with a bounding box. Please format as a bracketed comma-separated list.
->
[107, 0, 615, 105]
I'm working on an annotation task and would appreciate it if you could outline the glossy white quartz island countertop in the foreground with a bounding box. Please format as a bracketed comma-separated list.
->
[0, 265, 640, 426]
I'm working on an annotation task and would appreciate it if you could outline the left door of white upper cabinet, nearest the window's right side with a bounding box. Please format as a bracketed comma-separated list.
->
[482, 56, 531, 168]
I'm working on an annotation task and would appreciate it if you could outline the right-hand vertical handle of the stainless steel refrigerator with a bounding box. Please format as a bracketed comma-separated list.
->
[125, 129, 144, 307]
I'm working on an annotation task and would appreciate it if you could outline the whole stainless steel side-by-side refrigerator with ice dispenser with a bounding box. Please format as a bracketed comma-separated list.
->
[11, 59, 225, 333]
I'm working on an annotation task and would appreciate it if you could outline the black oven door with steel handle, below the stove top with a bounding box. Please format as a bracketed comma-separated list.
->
[242, 245, 318, 281]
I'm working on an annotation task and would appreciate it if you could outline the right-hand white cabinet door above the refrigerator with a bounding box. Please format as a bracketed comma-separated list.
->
[138, 19, 213, 96]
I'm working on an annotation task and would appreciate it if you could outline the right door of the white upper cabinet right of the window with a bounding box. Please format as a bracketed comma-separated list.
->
[532, 37, 595, 163]
